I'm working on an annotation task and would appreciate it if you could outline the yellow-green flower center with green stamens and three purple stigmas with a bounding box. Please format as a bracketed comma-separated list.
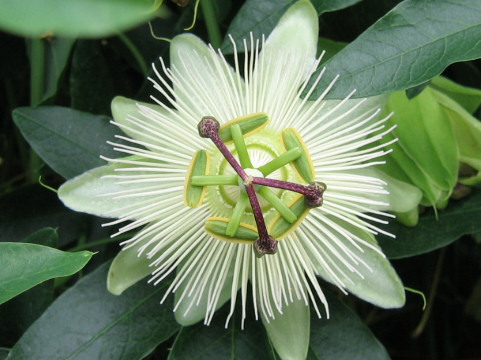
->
[184, 113, 326, 256]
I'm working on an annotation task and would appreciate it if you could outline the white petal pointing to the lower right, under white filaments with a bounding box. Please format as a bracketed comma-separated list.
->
[301, 216, 405, 308]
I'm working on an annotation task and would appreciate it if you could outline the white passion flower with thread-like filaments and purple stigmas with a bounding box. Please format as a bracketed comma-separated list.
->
[59, 0, 405, 358]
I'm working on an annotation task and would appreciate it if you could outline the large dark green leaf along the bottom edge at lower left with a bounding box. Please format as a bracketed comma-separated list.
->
[8, 264, 179, 360]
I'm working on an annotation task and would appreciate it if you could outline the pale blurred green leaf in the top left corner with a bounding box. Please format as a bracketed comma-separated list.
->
[0, 0, 161, 37]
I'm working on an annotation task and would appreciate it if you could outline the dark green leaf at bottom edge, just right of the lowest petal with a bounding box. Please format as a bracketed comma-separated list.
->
[307, 294, 390, 360]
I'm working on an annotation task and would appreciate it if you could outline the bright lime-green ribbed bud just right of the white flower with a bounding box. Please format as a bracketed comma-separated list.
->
[381, 87, 459, 210]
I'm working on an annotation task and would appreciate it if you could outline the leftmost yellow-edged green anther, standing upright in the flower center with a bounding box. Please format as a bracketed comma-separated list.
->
[184, 150, 209, 207]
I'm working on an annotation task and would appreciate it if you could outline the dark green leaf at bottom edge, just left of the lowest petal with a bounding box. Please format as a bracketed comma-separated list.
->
[168, 306, 269, 360]
